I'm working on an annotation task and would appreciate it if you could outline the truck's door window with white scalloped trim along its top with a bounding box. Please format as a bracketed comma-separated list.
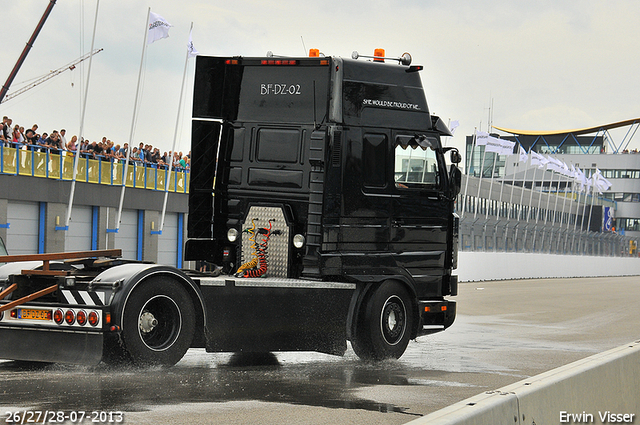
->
[394, 136, 440, 189]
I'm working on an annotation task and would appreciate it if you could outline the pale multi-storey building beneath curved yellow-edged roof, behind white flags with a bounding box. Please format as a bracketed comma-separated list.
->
[465, 120, 640, 238]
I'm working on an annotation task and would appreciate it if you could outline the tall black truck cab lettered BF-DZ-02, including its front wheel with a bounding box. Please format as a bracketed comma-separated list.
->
[185, 51, 460, 358]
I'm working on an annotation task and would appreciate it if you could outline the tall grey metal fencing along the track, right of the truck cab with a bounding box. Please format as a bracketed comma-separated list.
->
[457, 177, 638, 257]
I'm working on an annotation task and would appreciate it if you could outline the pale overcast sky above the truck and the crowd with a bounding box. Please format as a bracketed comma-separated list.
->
[0, 0, 640, 158]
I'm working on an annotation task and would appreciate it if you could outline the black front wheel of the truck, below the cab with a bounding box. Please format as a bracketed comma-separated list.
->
[351, 280, 415, 360]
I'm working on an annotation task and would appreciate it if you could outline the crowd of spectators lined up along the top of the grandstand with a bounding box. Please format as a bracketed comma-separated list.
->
[0, 116, 191, 170]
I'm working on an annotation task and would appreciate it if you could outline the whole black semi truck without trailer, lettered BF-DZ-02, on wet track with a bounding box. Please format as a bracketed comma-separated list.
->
[0, 48, 461, 365]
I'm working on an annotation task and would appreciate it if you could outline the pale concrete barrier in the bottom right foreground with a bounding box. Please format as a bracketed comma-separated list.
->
[409, 341, 640, 425]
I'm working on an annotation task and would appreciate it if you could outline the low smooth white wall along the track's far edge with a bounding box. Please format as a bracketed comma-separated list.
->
[456, 251, 640, 282]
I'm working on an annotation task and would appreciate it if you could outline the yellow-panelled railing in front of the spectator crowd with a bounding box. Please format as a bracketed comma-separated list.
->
[0, 144, 189, 193]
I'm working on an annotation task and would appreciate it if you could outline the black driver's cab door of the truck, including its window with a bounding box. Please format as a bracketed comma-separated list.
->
[389, 132, 451, 295]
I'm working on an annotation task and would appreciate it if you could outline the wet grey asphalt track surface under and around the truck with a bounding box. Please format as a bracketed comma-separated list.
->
[0, 277, 640, 424]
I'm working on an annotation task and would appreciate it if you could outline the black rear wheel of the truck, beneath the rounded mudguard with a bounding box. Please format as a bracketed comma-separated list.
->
[121, 277, 196, 366]
